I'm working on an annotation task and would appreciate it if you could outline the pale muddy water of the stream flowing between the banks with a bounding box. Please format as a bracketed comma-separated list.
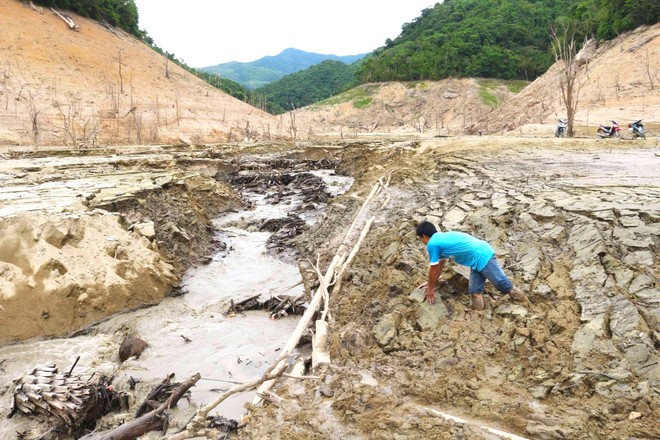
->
[0, 168, 351, 438]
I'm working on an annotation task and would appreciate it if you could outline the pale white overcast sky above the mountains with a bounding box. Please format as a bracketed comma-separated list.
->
[135, 0, 438, 67]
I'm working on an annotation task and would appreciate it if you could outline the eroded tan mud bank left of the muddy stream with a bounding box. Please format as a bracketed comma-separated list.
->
[0, 148, 241, 343]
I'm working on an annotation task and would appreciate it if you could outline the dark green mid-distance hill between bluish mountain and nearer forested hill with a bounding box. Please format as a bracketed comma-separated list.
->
[255, 60, 359, 114]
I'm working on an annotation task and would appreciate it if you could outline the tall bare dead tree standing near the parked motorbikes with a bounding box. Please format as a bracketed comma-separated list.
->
[550, 24, 580, 137]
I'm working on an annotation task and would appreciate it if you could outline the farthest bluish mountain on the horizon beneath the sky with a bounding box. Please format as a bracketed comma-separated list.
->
[200, 48, 367, 89]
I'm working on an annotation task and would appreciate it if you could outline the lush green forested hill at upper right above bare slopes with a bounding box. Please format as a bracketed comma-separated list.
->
[358, 0, 660, 83]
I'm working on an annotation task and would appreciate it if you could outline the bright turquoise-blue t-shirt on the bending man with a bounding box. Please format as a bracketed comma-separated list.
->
[426, 232, 495, 271]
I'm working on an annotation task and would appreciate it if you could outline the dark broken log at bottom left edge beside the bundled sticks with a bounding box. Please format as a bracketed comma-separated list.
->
[80, 373, 201, 440]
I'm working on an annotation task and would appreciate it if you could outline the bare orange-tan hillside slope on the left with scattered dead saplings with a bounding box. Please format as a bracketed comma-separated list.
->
[0, 0, 284, 148]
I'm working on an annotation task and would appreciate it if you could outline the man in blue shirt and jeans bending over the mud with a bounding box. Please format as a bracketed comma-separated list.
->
[416, 221, 529, 310]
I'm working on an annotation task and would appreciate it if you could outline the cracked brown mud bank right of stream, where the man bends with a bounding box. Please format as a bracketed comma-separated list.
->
[240, 138, 660, 439]
